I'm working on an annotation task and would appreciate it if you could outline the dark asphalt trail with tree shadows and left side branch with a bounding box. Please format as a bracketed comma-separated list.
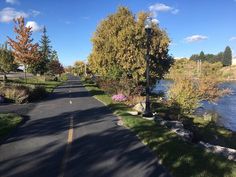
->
[0, 77, 170, 177]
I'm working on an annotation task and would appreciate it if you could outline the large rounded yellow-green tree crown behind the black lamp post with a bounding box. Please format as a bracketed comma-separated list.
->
[89, 7, 172, 85]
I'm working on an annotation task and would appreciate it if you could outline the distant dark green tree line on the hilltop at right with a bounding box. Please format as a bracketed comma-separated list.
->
[190, 46, 232, 66]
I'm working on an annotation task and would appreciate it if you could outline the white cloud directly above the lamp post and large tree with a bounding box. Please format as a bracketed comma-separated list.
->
[149, 3, 179, 17]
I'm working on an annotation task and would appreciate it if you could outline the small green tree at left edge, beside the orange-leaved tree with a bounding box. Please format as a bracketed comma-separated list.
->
[0, 43, 17, 83]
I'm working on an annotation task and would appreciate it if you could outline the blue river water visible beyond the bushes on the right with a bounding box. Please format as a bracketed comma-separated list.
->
[153, 80, 236, 131]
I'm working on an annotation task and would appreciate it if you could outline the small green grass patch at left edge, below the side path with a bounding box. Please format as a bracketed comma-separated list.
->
[0, 114, 22, 140]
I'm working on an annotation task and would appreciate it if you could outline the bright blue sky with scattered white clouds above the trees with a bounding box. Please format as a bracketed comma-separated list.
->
[0, 0, 236, 66]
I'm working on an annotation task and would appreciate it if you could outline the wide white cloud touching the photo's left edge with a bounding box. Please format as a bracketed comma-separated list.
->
[0, 7, 29, 23]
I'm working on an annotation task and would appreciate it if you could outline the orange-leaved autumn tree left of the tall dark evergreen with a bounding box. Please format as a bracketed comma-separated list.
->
[8, 17, 40, 82]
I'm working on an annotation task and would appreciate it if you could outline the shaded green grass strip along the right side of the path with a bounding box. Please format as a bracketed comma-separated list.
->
[85, 81, 236, 177]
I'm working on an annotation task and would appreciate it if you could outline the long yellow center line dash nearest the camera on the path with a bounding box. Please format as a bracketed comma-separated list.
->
[59, 116, 74, 177]
